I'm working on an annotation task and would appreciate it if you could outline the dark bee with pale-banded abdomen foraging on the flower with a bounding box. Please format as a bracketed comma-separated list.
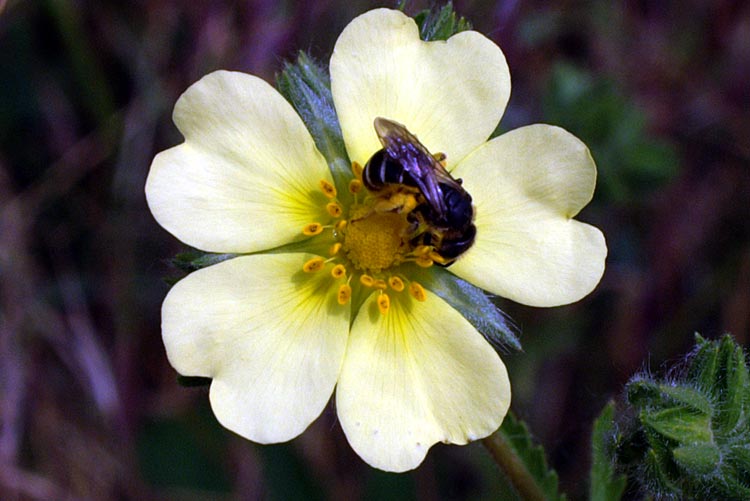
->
[362, 117, 477, 266]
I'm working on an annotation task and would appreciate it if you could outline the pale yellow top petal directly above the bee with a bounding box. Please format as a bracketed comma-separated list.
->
[331, 9, 510, 166]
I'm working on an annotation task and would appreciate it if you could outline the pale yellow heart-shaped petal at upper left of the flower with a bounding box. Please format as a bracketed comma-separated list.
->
[146, 71, 331, 252]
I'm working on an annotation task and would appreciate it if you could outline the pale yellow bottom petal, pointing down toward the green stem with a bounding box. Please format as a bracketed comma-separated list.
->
[336, 292, 510, 471]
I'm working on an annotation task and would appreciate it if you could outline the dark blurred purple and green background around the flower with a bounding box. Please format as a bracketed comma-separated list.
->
[0, 0, 750, 500]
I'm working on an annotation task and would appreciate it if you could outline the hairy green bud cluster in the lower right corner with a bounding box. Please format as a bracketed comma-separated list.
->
[619, 335, 750, 500]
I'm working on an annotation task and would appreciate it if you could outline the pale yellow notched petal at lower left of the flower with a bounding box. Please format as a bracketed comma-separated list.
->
[162, 254, 349, 443]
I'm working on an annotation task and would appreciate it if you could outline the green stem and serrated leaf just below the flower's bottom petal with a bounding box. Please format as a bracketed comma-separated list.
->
[485, 413, 566, 501]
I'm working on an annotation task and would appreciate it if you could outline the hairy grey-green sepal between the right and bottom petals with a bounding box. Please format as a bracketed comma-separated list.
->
[408, 265, 522, 351]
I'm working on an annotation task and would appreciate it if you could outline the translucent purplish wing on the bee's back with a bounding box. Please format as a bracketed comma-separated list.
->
[375, 117, 461, 216]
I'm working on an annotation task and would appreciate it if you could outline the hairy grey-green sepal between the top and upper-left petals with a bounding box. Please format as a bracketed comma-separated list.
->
[276, 51, 353, 202]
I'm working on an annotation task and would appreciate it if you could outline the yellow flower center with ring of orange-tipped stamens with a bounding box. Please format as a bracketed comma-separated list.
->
[302, 170, 428, 314]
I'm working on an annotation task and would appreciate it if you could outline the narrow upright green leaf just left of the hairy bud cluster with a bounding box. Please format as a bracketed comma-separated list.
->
[589, 402, 627, 501]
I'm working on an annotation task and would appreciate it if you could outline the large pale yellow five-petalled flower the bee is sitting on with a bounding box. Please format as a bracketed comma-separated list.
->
[146, 9, 606, 471]
